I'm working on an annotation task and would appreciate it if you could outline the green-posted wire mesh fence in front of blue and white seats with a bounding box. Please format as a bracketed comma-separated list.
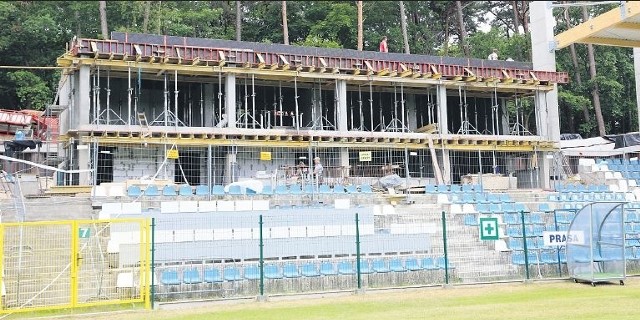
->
[110, 193, 640, 301]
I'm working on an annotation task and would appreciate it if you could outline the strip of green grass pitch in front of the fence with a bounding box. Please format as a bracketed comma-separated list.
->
[57, 278, 640, 320]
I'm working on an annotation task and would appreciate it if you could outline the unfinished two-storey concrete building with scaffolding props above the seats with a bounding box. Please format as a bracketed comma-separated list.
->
[55, 33, 568, 188]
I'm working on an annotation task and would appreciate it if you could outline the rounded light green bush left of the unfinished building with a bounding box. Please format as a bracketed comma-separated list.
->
[9, 71, 52, 110]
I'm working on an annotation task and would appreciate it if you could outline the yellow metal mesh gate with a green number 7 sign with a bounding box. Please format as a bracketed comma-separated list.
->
[0, 219, 151, 313]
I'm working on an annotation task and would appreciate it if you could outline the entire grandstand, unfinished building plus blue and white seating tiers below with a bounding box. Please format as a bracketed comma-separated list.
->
[0, 3, 640, 312]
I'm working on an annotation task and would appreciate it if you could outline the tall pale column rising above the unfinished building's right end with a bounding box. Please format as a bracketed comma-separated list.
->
[530, 1, 560, 142]
